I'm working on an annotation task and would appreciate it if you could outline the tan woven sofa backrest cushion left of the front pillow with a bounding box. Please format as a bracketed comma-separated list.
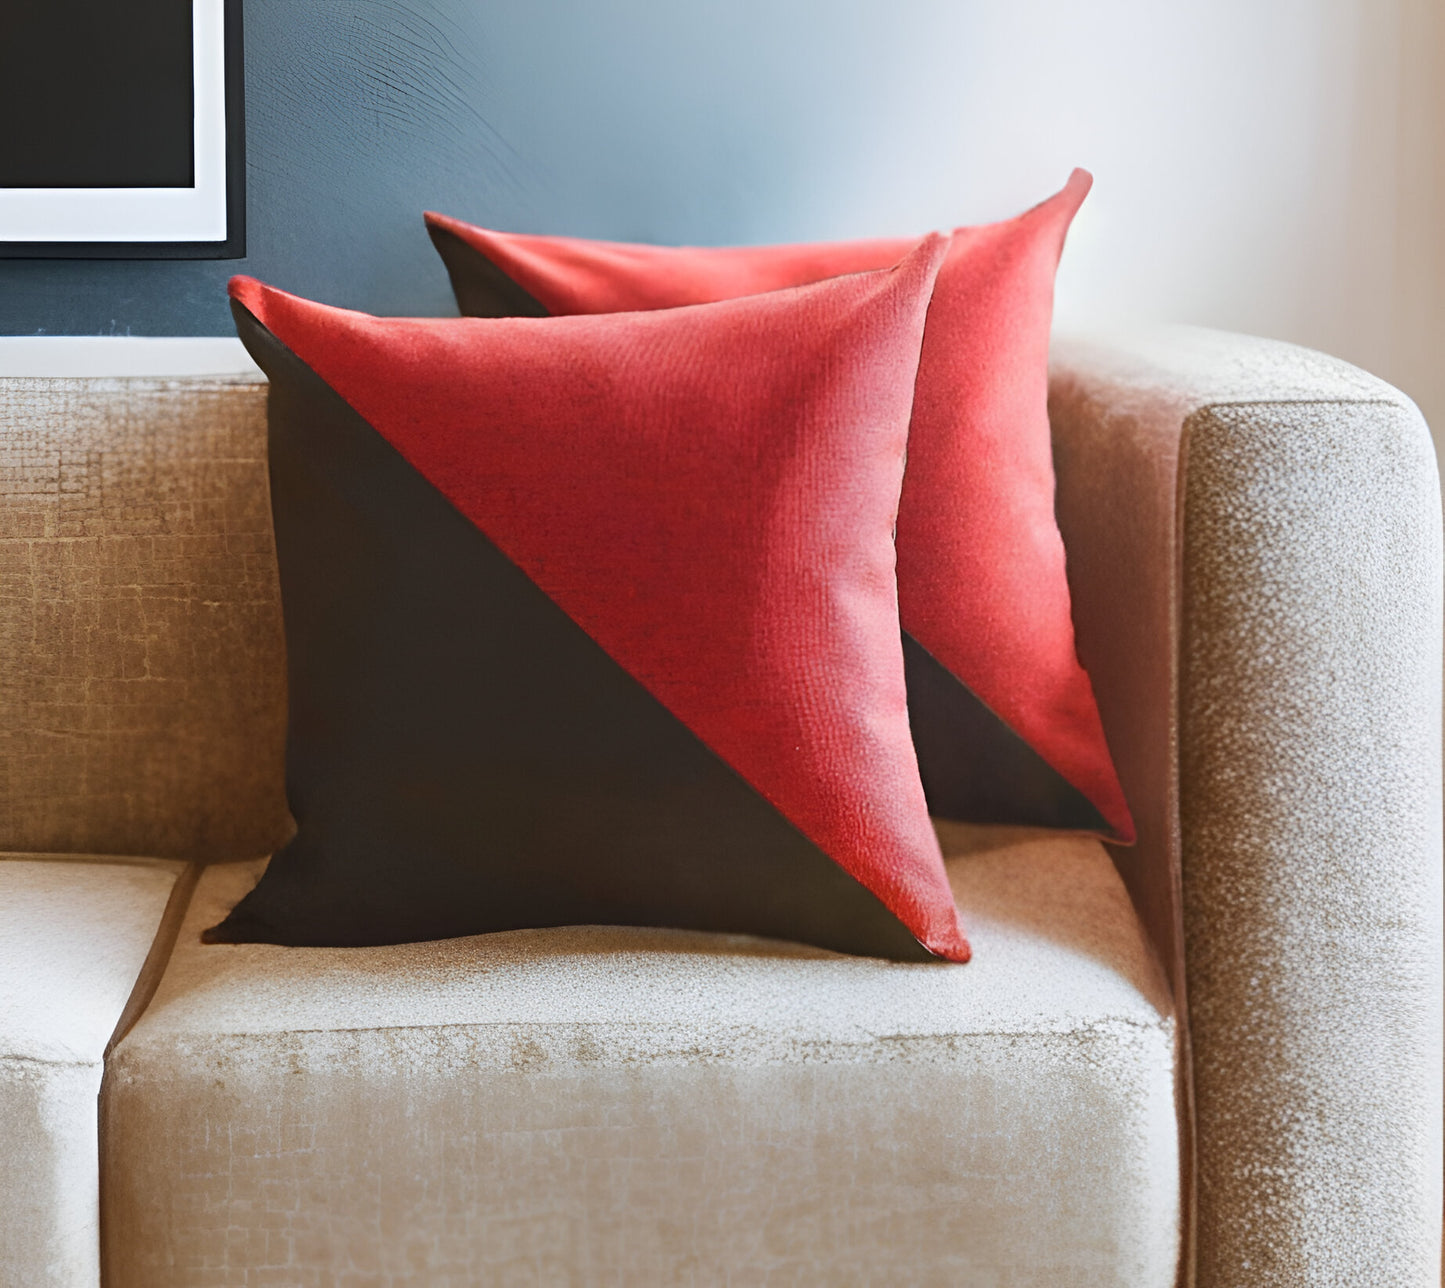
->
[0, 377, 290, 859]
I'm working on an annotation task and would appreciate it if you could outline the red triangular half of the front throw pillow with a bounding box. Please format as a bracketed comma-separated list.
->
[231, 236, 968, 961]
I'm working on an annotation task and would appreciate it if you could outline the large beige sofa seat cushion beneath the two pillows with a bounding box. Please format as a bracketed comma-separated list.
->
[101, 825, 1179, 1288]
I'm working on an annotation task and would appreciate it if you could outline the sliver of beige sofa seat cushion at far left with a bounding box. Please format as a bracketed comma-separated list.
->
[0, 854, 184, 1288]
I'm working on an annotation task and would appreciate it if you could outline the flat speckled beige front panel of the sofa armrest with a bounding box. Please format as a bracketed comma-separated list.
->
[1181, 400, 1442, 1288]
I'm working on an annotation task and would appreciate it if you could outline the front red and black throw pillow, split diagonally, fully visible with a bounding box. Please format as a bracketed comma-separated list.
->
[208, 237, 968, 961]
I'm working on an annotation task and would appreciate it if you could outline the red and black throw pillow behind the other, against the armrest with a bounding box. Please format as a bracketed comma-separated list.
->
[426, 171, 1134, 841]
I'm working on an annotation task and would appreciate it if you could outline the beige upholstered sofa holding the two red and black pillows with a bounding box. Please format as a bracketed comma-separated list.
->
[0, 330, 1442, 1288]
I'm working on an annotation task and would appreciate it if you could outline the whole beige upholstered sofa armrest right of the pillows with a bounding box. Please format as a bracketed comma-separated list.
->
[1049, 328, 1442, 1288]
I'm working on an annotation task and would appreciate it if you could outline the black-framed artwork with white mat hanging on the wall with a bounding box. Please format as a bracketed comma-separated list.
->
[0, 0, 246, 259]
